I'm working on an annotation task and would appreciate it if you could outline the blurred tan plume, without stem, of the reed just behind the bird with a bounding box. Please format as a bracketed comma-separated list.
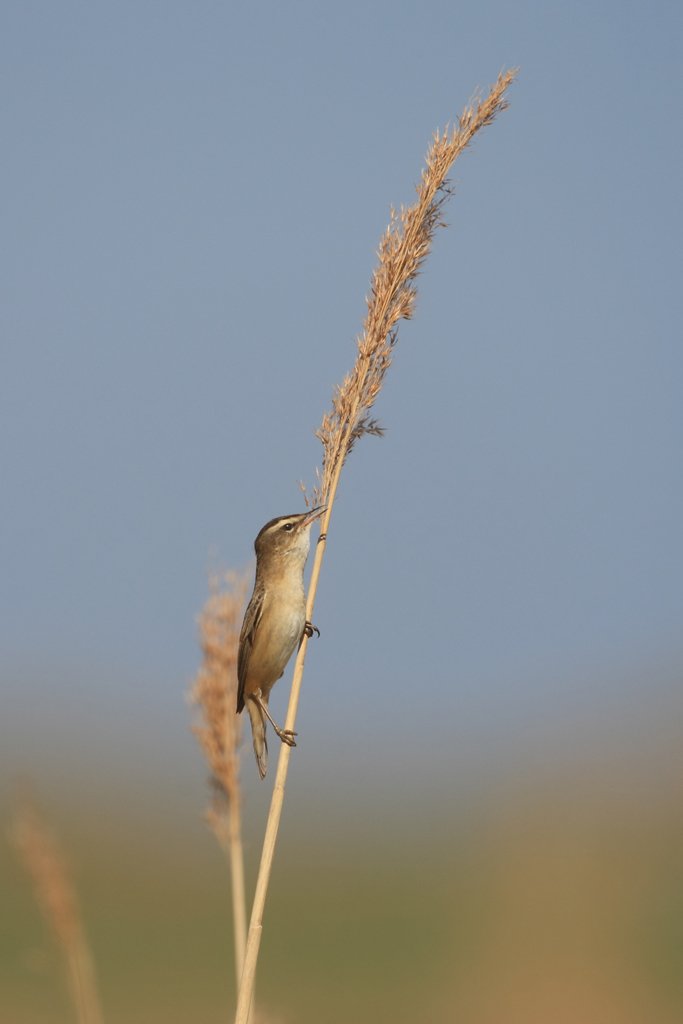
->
[189, 572, 248, 834]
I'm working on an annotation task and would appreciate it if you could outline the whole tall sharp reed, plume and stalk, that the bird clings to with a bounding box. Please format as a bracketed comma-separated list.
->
[236, 70, 516, 1024]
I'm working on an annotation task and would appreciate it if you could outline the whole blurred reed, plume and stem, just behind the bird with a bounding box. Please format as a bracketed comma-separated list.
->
[189, 572, 248, 984]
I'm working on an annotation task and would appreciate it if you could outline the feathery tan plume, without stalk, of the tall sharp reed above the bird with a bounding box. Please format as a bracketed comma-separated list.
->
[313, 70, 517, 505]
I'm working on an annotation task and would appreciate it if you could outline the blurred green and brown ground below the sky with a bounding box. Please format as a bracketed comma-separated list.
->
[0, 671, 683, 1024]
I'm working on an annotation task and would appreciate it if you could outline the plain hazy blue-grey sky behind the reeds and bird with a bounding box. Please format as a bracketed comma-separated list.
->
[0, 2, 683, 794]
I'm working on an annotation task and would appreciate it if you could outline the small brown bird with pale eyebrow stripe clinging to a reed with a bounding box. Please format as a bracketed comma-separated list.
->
[238, 505, 327, 778]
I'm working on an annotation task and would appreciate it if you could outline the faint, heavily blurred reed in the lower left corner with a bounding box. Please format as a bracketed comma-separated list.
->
[10, 797, 103, 1024]
